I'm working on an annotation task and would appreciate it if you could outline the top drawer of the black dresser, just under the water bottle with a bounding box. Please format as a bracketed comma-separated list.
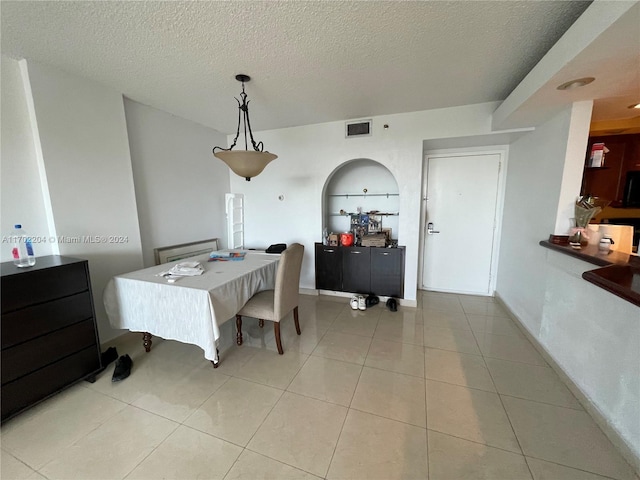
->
[1, 261, 89, 314]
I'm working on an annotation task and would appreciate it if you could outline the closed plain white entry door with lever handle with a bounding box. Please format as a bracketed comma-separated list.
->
[422, 153, 502, 295]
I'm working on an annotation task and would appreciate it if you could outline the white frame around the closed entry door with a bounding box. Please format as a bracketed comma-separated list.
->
[418, 145, 509, 297]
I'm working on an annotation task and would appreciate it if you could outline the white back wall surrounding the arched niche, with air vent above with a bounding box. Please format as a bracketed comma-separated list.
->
[231, 103, 497, 300]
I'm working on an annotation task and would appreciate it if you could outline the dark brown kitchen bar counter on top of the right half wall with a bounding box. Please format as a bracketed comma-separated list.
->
[540, 240, 640, 306]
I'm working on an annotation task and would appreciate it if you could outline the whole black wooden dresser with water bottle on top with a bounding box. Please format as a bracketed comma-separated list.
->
[0, 255, 101, 422]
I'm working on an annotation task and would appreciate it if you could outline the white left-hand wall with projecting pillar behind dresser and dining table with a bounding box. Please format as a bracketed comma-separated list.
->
[1, 60, 234, 342]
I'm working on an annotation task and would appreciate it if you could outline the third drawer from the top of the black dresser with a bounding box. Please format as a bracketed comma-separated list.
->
[2, 318, 100, 384]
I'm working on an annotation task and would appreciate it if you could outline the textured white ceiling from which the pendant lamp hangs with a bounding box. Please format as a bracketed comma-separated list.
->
[0, 0, 604, 133]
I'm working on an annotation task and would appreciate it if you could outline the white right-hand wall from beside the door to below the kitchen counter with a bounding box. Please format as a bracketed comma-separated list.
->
[496, 105, 640, 464]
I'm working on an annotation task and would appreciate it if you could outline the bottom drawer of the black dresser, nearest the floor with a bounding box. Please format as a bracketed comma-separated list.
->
[1, 347, 100, 421]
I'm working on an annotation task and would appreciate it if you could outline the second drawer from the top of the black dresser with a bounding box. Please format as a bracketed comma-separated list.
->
[2, 291, 93, 350]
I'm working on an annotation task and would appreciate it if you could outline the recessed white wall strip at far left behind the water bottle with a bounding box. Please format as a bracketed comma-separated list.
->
[0, 55, 53, 262]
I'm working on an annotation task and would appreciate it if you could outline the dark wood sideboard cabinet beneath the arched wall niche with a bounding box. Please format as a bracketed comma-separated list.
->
[315, 243, 405, 298]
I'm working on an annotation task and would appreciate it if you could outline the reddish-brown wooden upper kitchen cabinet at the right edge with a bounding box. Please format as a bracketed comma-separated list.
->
[581, 134, 640, 206]
